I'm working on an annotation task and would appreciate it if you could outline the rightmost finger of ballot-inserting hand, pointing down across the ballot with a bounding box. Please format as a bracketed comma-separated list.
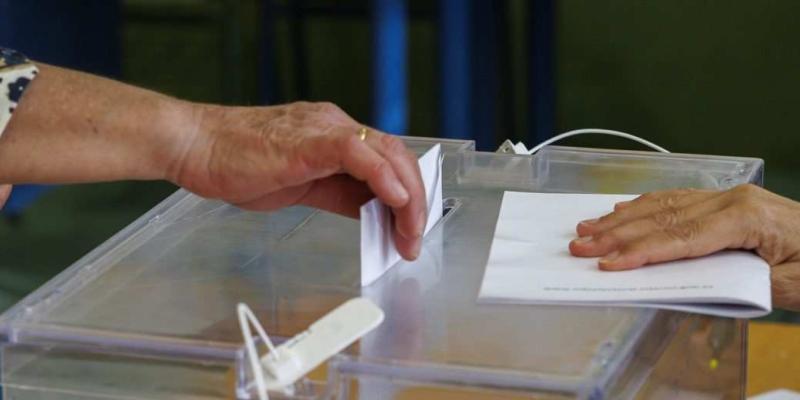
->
[366, 131, 428, 248]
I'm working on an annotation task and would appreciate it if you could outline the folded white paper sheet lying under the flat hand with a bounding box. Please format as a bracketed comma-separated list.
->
[480, 192, 772, 318]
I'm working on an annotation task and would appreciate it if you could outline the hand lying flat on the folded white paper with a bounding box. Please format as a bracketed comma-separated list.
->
[569, 185, 800, 310]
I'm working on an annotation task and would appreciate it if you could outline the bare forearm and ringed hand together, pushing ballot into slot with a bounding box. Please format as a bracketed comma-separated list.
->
[0, 59, 427, 259]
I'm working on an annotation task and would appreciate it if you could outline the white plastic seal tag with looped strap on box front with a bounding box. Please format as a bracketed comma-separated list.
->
[236, 297, 383, 400]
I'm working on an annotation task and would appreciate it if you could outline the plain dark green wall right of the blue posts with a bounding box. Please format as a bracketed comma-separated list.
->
[557, 0, 800, 198]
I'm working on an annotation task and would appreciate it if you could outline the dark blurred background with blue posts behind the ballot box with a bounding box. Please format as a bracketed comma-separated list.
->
[0, 0, 800, 320]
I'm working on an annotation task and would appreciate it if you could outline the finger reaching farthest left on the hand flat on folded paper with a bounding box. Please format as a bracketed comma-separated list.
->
[569, 197, 726, 257]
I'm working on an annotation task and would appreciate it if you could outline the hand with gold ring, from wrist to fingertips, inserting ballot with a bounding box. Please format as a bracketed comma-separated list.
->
[167, 103, 427, 259]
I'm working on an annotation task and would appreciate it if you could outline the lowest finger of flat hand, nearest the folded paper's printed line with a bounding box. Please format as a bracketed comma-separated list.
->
[598, 211, 745, 271]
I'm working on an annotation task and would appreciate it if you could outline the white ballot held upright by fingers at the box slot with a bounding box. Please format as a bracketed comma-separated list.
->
[360, 144, 442, 286]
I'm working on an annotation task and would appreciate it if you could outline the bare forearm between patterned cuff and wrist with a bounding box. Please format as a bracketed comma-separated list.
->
[0, 63, 196, 183]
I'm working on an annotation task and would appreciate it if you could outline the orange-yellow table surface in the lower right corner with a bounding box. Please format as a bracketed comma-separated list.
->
[747, 322, 800, 396]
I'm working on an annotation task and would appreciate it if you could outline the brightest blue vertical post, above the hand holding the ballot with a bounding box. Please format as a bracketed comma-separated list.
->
[372, 0, 408, 134]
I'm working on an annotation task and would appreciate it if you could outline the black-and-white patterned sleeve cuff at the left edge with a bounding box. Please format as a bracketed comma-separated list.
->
[0, 47, 39, 135]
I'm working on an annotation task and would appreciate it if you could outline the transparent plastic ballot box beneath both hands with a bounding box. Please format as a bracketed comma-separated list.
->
[0, 138, 763, 399]
